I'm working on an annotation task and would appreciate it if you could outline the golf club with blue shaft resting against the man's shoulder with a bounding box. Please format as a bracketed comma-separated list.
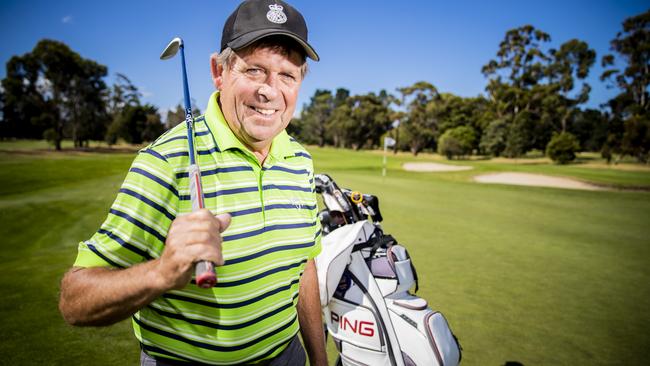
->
[160, 37, 217, 288]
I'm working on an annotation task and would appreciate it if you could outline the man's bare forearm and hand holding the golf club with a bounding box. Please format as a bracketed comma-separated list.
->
[59, 209, 230, 325]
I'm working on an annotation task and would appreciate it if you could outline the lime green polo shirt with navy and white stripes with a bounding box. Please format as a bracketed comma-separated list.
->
[74, 93, 320, 365]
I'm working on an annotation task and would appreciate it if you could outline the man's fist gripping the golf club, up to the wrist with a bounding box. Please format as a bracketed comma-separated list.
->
[156, 209, 230, 290]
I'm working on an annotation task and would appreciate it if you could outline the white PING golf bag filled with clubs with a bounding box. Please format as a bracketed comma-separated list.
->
[315, 174, 461, 366]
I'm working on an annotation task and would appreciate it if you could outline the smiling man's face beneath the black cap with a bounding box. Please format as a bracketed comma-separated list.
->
[215, 48, 302, 152]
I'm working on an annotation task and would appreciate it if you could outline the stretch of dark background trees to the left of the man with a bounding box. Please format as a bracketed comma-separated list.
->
[0, 39, 198, 150]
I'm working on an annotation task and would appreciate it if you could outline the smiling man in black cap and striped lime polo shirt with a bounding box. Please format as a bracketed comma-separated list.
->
[59, 0, 327, 365]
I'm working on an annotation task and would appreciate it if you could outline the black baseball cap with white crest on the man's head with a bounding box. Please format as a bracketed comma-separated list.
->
[221, 0, 320, 61]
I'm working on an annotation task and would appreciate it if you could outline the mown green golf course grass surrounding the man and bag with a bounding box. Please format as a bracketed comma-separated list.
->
[0, 141, 650, 366]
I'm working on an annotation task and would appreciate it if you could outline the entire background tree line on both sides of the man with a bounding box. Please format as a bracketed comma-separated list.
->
[0, 11, 650, 162]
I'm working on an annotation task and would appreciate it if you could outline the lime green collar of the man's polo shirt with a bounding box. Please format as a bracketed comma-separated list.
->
[205, 91, 295, 160]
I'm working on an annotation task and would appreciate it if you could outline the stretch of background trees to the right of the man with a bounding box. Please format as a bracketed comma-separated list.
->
[289, 11, 650, 163]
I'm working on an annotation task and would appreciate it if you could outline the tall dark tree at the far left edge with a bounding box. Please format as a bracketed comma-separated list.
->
[1, 39, 108, 150]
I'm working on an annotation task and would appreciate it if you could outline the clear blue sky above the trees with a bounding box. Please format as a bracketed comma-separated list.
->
[0, 0, 650, 115]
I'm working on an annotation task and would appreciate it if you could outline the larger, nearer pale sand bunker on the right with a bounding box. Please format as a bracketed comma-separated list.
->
[474, 173, 605, 191]
